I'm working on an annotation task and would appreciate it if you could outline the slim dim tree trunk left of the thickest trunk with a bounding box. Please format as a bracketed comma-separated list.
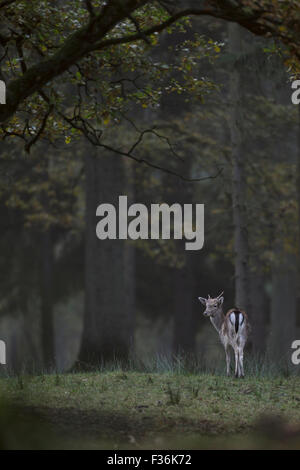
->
[40, 228, 55, 369]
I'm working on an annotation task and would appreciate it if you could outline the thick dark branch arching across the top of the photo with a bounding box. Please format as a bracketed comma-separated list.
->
[0, 0, 300, 123]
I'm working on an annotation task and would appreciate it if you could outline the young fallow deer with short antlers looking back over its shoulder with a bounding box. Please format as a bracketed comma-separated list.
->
[198, 292, 250, 377]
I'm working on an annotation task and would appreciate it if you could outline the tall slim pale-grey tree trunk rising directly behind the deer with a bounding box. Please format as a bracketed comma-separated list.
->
[228, 23, 249, 310]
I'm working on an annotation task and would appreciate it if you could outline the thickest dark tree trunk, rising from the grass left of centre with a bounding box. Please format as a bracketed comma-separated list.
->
[78, 149, 135, 368]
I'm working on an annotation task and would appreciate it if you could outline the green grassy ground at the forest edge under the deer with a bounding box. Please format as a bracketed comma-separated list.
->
[0, 370, 300, 449]
